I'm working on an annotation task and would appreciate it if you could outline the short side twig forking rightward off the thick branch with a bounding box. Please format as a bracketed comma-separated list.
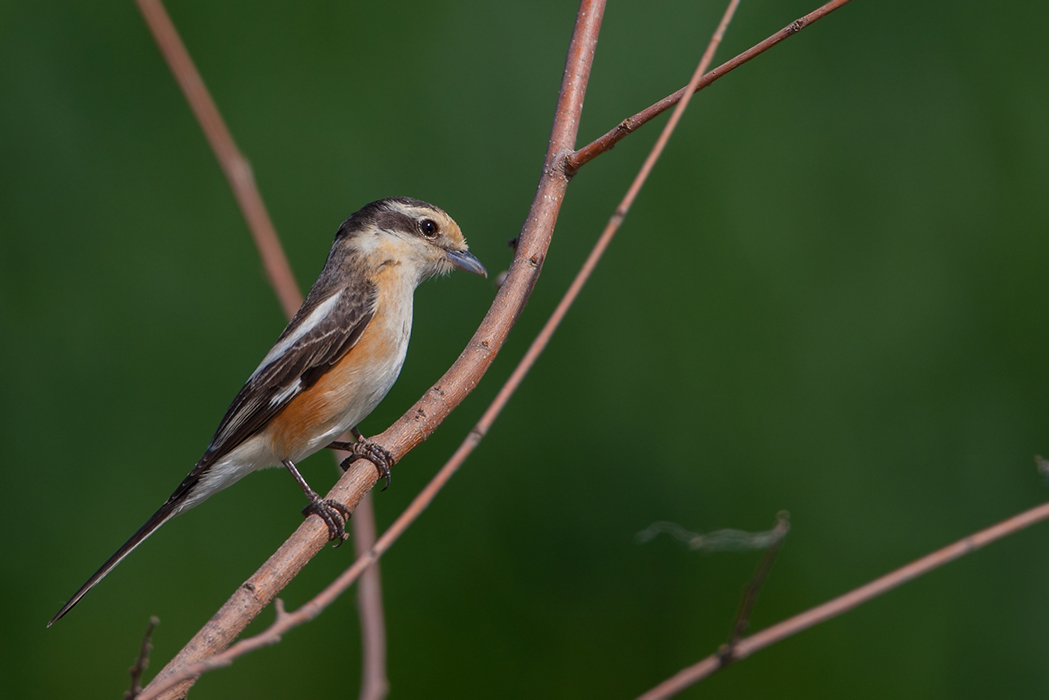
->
[565, 0, 849, 175]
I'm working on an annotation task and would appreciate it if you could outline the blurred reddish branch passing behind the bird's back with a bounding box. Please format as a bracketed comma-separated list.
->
[137, 0, 388, 700]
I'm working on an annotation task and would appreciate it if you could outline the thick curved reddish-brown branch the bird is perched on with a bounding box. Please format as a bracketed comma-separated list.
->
[143, 0, 604, 698]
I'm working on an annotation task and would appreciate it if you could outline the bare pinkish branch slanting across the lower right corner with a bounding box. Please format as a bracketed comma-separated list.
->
[639, 503, 1049, 700]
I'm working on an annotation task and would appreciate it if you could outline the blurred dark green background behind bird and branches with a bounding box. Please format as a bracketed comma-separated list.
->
[0, 0, 1049, 699]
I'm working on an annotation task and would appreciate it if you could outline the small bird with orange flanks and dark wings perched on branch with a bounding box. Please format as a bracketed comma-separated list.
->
[47, 197, 488, 627]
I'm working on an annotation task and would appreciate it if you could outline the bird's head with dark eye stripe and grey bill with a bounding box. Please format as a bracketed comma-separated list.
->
[333, 197, 488, 284]
